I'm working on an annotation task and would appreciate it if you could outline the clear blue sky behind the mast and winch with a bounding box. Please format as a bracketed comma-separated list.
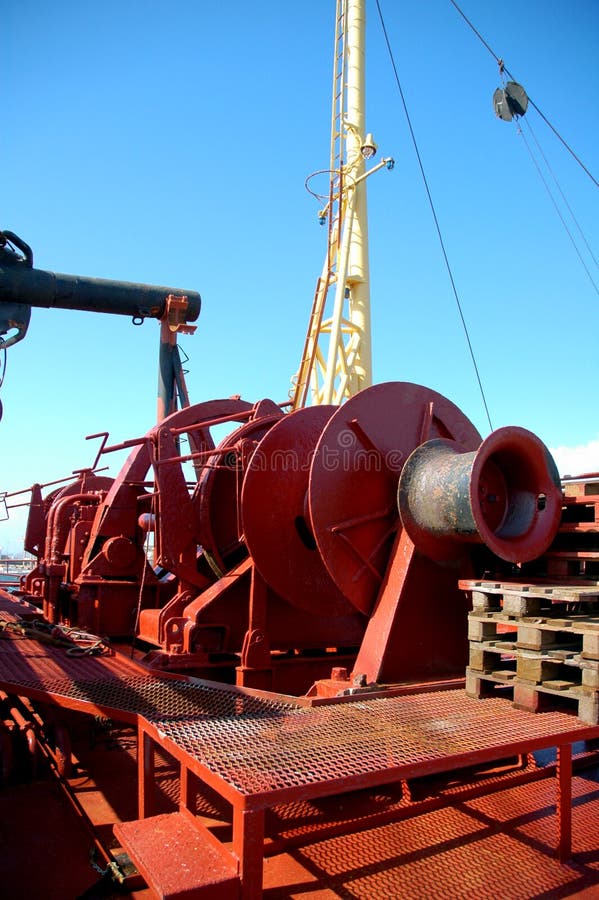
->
[0, 0, 599, 550]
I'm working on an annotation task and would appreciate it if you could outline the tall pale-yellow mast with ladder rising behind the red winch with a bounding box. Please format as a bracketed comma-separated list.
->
[291, 0, 394, 409]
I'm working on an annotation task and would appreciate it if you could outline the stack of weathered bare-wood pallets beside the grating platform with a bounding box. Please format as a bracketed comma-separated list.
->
[460, 580, 599, 725]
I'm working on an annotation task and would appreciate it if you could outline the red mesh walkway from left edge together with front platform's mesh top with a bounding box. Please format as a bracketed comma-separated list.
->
[0, 596, 599, 796]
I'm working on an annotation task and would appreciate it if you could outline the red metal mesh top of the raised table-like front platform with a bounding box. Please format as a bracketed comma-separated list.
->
[152, 690, 599, 796]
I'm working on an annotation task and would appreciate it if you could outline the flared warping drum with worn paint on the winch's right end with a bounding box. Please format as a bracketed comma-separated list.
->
[398, 426, 562, 562]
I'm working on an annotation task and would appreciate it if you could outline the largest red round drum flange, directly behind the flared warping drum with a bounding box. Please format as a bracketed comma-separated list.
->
[308, 381, 481, 613]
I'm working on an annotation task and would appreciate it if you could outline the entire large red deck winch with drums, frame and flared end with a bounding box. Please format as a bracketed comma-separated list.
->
[17, 382, 562, 694]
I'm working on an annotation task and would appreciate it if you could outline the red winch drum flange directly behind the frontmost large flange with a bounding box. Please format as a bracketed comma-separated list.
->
[241, 406, 352, 616]
